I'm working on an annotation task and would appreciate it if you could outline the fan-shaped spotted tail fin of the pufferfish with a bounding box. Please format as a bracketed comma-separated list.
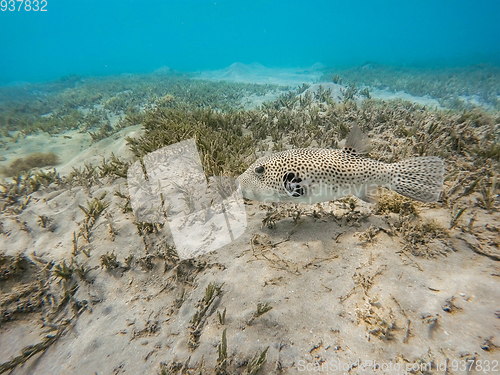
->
[391, 156, 444, 202]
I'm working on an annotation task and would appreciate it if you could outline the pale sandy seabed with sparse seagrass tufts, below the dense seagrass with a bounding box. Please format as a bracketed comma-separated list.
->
[0, 66, 500, 374]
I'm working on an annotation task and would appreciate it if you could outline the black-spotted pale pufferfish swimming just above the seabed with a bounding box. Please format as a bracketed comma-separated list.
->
[237, 125, 444, 204]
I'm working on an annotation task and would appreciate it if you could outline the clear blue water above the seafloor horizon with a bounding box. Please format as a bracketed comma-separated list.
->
[0, 0, 500, 83]
